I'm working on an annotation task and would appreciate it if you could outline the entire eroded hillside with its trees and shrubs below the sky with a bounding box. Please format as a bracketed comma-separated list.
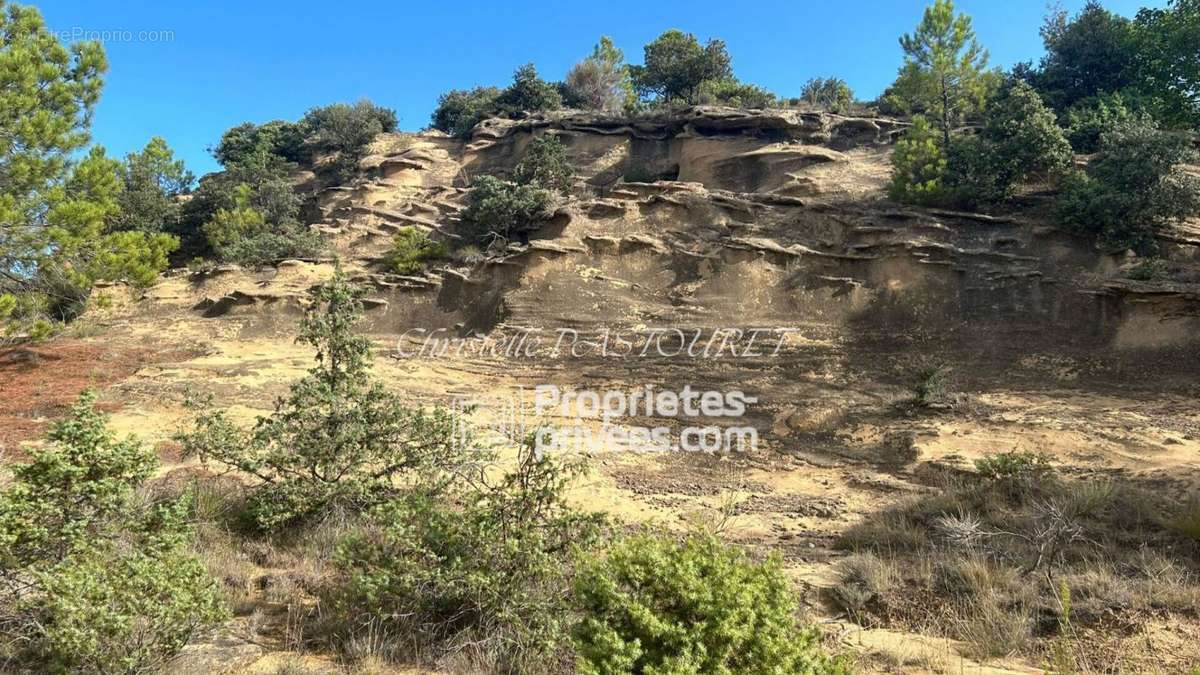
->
[0, 0, 1200, 674]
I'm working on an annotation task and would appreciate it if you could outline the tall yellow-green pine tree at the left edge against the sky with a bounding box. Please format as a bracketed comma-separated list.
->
[0, 0, 178, 336]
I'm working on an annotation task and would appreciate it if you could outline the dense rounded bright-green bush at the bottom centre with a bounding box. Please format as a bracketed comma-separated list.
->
[576, 536, 840, 674]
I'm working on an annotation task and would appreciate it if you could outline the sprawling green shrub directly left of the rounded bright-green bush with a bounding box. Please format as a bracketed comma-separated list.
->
[334, 437, 600, 673]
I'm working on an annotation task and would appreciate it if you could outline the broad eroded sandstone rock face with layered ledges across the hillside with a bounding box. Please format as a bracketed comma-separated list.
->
[187, 107, 1200, 374]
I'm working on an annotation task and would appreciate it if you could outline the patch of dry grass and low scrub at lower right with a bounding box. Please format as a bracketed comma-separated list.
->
[828, 452, 1200, 671]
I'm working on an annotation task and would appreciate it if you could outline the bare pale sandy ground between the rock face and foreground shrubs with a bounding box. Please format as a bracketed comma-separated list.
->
[2, 275, 1200, 673]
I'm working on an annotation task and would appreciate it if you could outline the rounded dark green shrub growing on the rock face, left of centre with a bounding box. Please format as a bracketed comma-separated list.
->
[460, 175, 551, 246]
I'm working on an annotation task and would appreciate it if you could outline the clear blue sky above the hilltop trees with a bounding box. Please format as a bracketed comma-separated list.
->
[34, 0, 1164, 174]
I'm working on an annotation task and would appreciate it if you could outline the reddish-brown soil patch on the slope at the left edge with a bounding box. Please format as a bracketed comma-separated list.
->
[0, 340, 194, 458]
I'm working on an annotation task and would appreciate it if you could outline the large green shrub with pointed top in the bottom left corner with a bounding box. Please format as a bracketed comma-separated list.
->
[0, 393, 224, 673]
